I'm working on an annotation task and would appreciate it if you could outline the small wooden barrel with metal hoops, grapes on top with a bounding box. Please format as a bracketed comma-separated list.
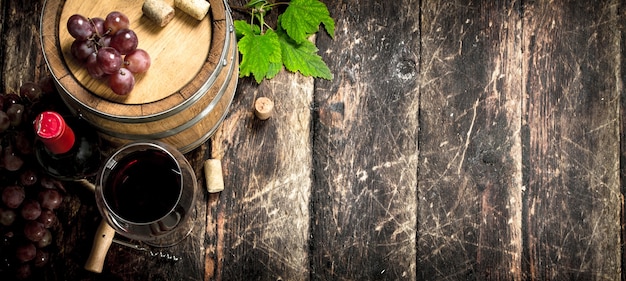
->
[41, 0, 239, 153]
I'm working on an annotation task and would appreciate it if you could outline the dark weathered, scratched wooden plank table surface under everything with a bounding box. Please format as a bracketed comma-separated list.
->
[0, 0, 626, 280]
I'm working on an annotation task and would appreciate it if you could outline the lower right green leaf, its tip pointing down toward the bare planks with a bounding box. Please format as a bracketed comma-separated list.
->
[277, 29, 333, 80]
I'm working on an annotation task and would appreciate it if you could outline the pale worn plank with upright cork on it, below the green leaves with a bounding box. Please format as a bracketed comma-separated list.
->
[208, 72, 313, 280]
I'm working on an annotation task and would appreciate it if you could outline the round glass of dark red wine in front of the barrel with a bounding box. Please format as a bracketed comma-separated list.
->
[96, 140, 197, 247]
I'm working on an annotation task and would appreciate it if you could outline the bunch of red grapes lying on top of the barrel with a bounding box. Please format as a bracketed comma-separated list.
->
[67, 11, 151, 95]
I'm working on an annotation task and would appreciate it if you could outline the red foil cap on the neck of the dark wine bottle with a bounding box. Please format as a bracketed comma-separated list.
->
[34, 111, 75, 154]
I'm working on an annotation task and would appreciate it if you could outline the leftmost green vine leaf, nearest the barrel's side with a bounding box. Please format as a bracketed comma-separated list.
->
[235, 27, 282, 83]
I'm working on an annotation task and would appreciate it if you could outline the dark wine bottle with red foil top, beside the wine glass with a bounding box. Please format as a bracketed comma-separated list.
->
[34, 111, 102, 180]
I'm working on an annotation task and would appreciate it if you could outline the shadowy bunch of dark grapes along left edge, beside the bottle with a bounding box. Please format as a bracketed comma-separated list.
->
[0, 79, 65, 280]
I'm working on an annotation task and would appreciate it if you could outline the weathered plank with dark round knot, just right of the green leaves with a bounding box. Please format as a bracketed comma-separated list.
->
[311, 0, 420, 280]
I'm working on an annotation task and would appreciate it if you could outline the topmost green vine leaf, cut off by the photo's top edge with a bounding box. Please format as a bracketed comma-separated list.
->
[280, 0, 335, 44]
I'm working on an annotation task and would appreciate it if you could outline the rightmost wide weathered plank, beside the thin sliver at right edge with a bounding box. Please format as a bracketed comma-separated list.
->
[523, 1, 622, 280]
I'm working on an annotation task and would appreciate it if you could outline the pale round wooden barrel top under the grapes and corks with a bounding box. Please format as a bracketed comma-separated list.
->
[57, 0, 213, 104]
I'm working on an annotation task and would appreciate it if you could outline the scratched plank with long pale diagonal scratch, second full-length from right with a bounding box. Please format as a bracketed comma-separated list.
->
[418, 0, 522, 280]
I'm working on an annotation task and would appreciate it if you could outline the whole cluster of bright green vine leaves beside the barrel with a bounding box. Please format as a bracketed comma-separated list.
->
[235, 0, 335, 83]
